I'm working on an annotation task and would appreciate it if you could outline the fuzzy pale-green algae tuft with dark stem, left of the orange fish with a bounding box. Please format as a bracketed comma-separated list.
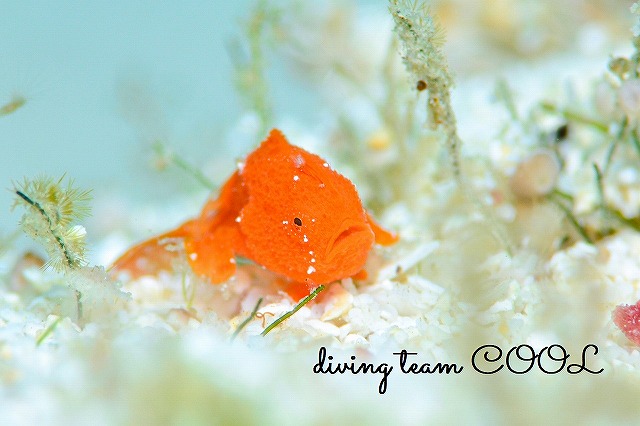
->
[14, 176, 91, 271]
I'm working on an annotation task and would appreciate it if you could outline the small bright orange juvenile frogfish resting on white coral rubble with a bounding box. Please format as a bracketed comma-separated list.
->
[113, 129, 398, 299]
